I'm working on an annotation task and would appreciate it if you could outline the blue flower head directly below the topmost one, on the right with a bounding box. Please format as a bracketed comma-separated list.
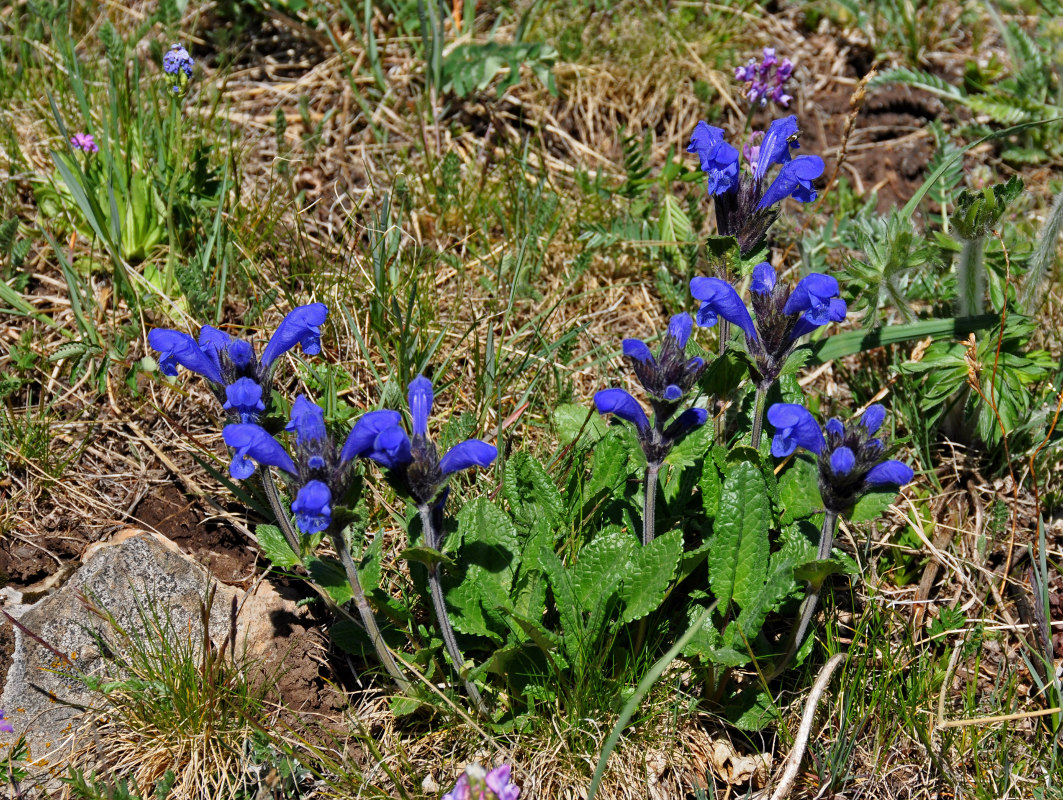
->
[690, 261, 846, 389]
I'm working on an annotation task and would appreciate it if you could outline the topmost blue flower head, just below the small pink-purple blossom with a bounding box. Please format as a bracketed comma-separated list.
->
[687, 115, 824, 257]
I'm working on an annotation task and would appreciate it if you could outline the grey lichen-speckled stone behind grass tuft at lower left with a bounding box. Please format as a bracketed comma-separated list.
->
[0, 530, 301, 788]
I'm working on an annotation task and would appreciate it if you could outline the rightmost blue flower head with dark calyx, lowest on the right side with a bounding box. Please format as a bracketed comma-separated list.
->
[767, 403, 915, 513]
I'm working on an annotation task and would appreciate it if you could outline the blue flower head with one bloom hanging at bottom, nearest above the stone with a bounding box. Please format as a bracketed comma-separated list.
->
[222, 395, 376, 534]
